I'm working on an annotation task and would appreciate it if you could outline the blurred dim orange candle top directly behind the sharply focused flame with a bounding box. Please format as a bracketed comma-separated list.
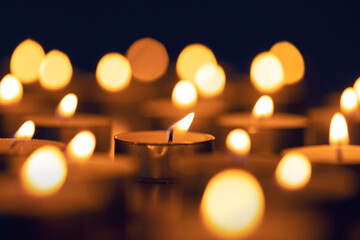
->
[143, 98, 226, 118]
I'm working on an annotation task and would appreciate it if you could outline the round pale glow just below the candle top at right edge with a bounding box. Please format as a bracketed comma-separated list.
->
[275, 153, 311, 190]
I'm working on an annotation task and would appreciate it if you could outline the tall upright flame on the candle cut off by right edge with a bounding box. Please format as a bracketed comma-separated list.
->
[329, 113, 349, 145]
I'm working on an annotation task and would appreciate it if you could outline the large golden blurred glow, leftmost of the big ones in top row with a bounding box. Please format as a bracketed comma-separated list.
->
[10, 39, 45, 83]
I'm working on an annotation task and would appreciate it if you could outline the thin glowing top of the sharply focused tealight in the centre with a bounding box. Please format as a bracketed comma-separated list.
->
[114, 130, 215, 146]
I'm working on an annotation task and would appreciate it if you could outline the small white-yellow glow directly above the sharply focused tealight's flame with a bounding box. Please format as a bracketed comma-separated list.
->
[171, 80, 197, 108]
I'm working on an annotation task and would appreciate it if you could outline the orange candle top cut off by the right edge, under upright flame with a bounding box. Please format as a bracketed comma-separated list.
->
[284, 145, 360, 165]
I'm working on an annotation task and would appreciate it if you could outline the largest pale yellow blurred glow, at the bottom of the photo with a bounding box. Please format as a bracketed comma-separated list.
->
[200, 169, 265, 238]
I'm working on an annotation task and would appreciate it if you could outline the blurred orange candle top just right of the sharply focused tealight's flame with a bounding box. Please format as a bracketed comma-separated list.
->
[218, 113, 307, 129]
